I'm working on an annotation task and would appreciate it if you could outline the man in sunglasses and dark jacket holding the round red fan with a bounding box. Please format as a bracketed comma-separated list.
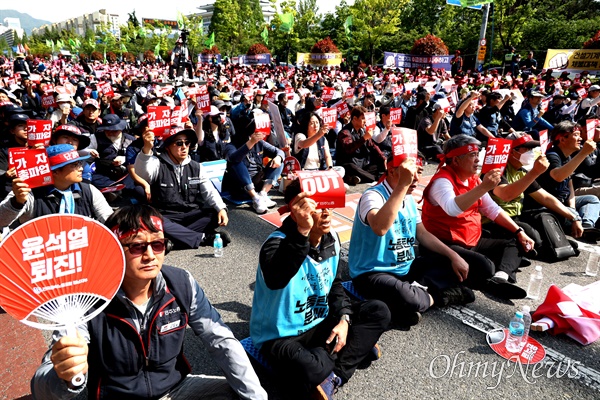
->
[31, 205, 267, 399]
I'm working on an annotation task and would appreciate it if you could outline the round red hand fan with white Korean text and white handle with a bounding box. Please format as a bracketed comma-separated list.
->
[0, 214, 125, 386]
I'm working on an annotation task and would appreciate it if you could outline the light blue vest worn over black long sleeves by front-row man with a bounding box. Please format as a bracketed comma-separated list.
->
[250, 231, 340, 349]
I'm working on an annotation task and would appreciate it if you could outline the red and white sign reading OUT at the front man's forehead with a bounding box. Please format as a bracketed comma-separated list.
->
[296, 170, 346, 208]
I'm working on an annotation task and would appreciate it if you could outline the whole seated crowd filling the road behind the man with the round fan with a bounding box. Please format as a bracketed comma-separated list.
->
[0, 48, 600, 398]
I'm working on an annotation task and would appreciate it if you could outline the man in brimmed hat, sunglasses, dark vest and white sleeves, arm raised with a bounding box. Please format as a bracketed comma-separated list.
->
[135, 127, 231, 249]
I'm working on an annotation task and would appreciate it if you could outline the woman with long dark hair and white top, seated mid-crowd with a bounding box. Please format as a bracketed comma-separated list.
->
[294, 111, 344, 177]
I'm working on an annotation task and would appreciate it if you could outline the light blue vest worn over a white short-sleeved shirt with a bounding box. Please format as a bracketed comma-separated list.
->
[348, 184, 419, 278]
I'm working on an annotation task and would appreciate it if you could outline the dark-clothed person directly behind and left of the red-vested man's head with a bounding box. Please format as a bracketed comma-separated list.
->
[417, 103, 450, 161]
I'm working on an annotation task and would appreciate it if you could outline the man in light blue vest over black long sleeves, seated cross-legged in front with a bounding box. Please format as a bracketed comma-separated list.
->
[250, 180, 390, 399]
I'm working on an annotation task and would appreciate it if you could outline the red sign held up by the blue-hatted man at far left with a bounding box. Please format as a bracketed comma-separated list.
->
[8, 148, 54, 189]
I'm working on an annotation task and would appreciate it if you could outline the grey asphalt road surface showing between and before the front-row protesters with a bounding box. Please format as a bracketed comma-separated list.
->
[12, 170, 600, 400]
